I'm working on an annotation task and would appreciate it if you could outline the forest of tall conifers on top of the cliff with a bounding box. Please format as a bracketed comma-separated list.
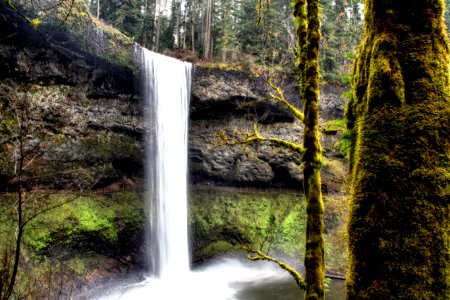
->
[81, 0, 450, 84]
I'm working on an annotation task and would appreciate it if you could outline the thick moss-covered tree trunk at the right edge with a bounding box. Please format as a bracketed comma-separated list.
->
[347, 0, 450, 299]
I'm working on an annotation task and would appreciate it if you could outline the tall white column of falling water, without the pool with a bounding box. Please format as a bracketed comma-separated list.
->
[142, 49, 192, 278]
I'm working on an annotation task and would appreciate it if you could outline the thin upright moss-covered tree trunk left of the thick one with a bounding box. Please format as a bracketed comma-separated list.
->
[294, 0, 325, 299]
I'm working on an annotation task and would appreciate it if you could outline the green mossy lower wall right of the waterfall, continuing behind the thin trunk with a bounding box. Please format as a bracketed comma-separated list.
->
[189, 187, 346, 274]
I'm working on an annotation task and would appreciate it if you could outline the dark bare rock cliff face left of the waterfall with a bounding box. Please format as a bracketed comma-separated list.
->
[0, 5, 144, 190]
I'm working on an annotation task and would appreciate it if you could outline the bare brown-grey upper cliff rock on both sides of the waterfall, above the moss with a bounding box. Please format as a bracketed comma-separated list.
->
[0, 4, 344, 191]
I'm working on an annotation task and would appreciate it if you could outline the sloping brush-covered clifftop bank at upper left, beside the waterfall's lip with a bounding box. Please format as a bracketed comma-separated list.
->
[10, 0, 134, 68]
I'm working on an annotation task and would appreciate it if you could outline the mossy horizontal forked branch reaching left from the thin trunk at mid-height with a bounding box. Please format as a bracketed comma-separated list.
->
[213, 124, 305, 154]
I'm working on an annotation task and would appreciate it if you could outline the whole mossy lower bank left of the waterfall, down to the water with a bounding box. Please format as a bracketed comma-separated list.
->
[0, 192, 145, 299]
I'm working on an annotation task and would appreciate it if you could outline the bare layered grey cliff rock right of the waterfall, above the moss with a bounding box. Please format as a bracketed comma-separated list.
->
[189, 67, 344, 190]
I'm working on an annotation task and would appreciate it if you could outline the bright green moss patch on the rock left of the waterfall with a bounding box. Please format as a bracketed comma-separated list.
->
[0, 192, 145, 268]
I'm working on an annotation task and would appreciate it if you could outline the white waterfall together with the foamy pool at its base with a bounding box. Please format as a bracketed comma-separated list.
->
[92, 49, 344, 300]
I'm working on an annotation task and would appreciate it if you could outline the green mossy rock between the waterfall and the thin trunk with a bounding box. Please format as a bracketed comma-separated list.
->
[189, 188, 305, 258]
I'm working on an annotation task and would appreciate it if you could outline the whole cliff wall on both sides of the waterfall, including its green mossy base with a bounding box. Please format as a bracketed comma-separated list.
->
[0, 5, 345, 290]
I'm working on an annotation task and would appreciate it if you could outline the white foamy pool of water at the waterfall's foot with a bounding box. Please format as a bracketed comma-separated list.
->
[92, 259, 345, 300]
